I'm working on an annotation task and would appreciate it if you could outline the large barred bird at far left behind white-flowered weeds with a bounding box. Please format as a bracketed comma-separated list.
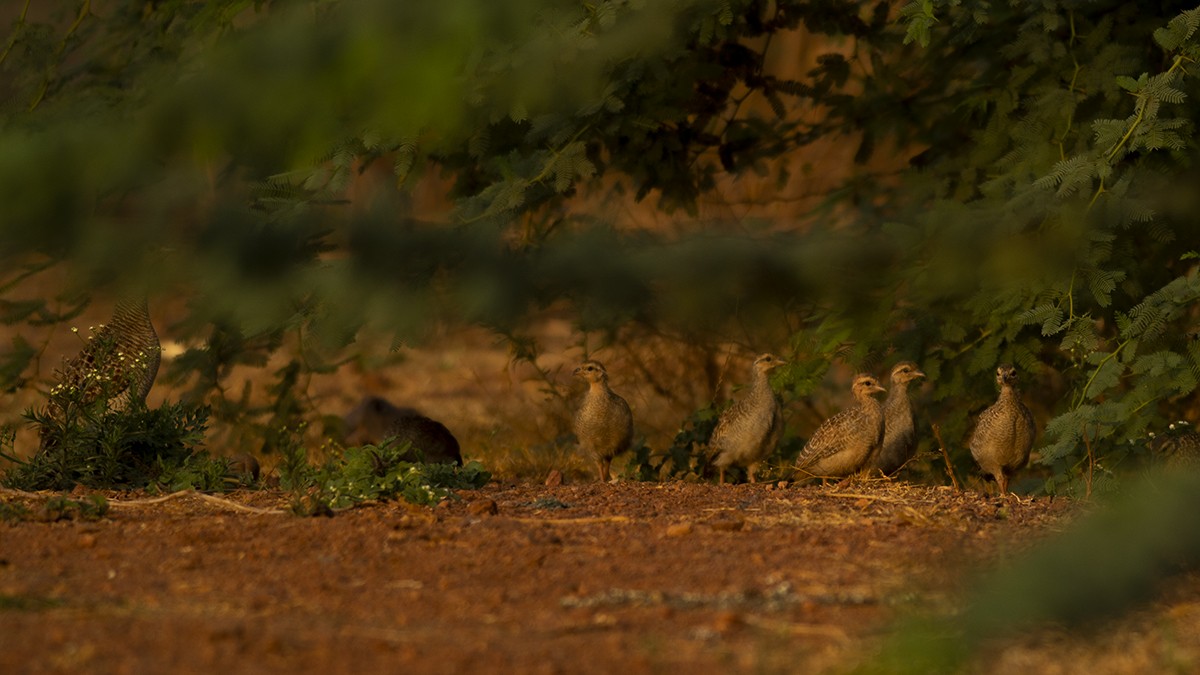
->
[49, 298, 162, 417]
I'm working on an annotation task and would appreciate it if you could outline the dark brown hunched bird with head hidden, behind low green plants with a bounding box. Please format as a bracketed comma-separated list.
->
[342, 396, 462, 465]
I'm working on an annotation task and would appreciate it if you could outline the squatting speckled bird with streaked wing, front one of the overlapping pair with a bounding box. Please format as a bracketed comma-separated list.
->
[796, 374, 886, 478]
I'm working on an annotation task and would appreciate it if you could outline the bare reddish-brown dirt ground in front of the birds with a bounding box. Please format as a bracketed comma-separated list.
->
[0, 480, 1200, 673]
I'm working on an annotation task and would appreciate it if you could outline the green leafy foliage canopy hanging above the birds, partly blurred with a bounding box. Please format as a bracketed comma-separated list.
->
[0, 0, 1200, 488]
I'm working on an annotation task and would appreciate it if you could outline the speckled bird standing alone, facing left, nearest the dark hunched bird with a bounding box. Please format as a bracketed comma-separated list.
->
[575, 359, 634, 483]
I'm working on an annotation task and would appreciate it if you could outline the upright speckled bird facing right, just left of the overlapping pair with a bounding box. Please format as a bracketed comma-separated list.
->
[708, 354, 786, 483]
